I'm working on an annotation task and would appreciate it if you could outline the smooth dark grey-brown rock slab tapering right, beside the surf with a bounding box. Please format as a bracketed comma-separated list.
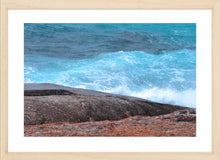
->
[24, 83, 189, 125]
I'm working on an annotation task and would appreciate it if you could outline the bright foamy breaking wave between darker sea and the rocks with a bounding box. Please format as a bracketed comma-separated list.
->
[24, 50, 196, 107]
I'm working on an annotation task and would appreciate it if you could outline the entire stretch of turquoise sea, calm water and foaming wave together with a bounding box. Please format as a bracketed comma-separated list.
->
[24, 23, 196, 107]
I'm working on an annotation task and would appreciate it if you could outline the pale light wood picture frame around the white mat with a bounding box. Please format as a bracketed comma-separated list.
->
[0, 0, 220, 160]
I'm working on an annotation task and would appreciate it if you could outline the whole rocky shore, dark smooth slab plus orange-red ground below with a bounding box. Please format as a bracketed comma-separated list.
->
[24, 83, 196, 136]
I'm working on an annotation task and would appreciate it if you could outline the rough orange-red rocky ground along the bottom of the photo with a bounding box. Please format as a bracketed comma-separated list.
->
[24, 110, 196, 137]
